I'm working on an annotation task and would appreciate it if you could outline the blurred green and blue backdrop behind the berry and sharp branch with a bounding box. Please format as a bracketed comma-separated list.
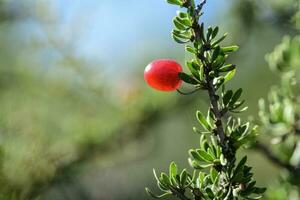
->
[0, 0, 295, 200]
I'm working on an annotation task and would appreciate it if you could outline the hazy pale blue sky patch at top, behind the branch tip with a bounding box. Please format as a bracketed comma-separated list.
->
[42, 0, 228, 73]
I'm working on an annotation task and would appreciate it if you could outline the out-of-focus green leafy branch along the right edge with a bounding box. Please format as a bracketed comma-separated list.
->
[257, 14, 300, 200]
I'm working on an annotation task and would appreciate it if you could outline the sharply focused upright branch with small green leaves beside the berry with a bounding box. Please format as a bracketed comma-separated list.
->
[146, 0, 265, 200]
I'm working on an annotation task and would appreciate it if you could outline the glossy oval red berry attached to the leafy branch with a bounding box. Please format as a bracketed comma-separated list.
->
[144, 59, 182, 91]
